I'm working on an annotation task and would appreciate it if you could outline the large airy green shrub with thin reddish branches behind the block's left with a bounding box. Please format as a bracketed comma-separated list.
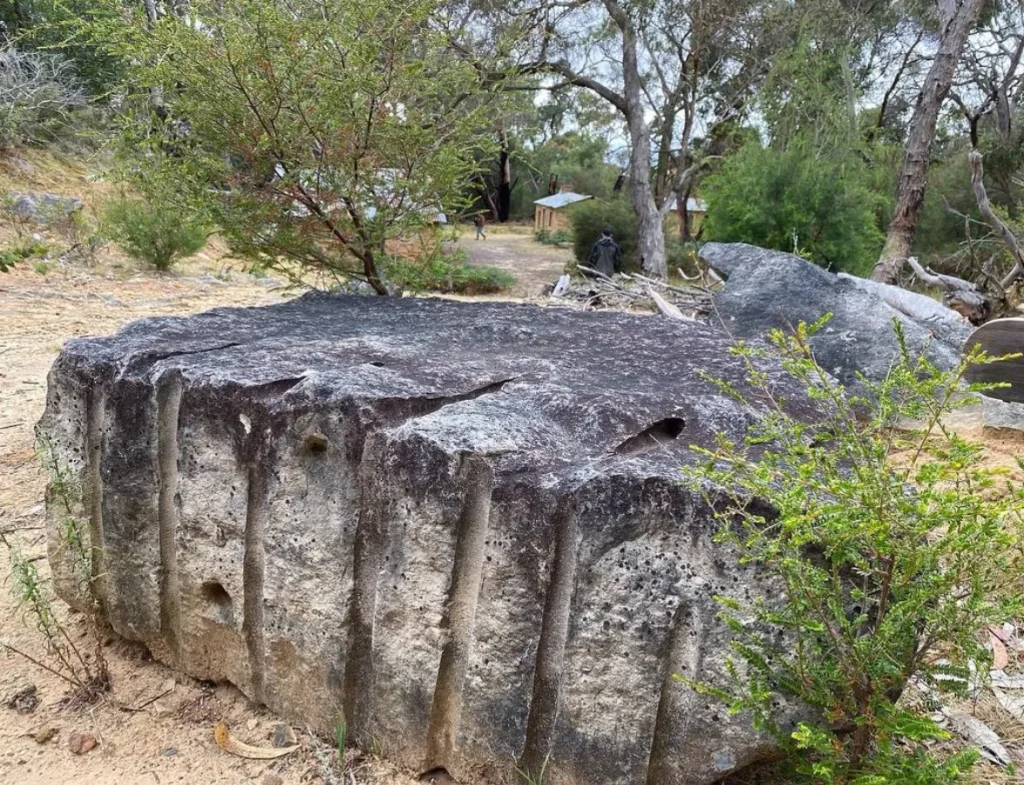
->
[101, 0, 496, 294]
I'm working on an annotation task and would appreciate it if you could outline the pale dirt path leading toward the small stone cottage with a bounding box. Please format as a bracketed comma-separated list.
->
[455, 226, 572, 298]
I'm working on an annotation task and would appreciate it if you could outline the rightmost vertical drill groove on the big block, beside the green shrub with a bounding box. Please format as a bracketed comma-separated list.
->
[646, 599, 707, 785]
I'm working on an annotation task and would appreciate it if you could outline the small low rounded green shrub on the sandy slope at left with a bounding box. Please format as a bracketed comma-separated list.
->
[103, 200, 210, 270]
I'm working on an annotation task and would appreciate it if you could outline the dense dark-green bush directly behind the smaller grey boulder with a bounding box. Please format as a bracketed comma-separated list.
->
[701, 142, 884, 274]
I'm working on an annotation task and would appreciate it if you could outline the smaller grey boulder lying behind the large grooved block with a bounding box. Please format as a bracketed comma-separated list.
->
[700, 243, 971, 388]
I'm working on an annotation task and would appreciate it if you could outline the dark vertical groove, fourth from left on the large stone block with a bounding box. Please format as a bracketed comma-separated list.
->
[342, 436, 387, 745]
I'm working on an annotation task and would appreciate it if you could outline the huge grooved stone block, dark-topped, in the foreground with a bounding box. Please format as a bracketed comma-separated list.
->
[40, 295, 810, 785]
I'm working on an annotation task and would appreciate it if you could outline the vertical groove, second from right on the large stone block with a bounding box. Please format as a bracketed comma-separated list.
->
[519, 496, 580, 777]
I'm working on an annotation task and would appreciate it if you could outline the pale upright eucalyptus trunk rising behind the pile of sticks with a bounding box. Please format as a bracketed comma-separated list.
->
[618, 19, 669, 280]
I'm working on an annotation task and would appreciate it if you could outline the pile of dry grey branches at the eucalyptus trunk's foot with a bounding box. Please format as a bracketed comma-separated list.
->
[550, 265, 721, 319]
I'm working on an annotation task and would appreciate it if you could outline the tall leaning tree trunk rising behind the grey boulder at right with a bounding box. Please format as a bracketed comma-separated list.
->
[871, 0, 985, 284]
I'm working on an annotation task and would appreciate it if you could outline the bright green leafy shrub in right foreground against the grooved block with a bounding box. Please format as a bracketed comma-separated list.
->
[677, 317, 1024, 785]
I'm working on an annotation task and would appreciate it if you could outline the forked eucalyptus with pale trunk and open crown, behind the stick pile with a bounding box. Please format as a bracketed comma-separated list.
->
[453, 0, 788, 277]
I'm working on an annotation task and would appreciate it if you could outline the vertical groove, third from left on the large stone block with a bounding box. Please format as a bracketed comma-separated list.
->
[242, 457, 268, 701]
